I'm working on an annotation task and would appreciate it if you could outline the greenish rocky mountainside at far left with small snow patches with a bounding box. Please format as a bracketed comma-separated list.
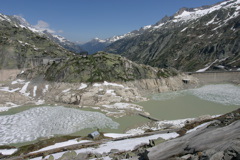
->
[0, 14, 74, 69]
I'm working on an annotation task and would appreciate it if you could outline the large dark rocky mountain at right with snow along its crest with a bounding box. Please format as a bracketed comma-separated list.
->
[106, 0, 240, 71]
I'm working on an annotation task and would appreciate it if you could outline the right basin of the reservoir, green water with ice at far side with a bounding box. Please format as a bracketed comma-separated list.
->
[137, 84, 240, 120]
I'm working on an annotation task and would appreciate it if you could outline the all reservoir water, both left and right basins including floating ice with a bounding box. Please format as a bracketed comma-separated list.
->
[0, 84, 240, 145]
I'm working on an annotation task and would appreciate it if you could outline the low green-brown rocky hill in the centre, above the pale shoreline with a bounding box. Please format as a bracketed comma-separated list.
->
[19, 52, 177, 82]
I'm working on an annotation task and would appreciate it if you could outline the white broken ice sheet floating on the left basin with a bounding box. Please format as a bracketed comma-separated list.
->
[0, 106, 119, 145]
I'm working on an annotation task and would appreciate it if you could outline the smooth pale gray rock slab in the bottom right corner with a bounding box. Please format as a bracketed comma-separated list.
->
[148, 120, 240, 160]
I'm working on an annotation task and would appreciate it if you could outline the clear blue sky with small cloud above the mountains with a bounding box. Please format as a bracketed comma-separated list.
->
[0, 0, 221, 42]
